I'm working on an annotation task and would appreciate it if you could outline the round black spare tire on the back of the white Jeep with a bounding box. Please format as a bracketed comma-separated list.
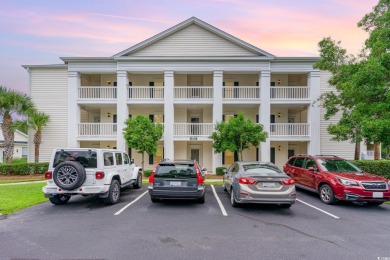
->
[53, 161, 87, 190]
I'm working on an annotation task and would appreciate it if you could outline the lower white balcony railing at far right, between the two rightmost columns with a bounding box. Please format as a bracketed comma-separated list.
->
[269, 123, 310, 141]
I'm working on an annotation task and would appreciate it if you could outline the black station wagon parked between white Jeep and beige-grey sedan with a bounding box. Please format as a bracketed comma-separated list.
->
[148, 159, 206, 203]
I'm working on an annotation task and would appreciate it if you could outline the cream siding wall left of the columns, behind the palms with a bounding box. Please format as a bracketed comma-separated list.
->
[28, 68, 68, 162]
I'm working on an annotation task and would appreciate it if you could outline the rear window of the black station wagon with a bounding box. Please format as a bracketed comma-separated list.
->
[155, 163, 197, 178]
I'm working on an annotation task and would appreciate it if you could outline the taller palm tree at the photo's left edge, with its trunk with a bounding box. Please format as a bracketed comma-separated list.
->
[0, 86, 35, 163]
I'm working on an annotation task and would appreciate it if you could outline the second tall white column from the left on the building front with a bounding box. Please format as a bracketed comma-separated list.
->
[116, 70, 129, 150]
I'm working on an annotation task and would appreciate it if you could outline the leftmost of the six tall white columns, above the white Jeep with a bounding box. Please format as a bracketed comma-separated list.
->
[68, 71, 81, 148]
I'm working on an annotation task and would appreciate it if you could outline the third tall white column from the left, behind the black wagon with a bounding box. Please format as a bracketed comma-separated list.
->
[164, 71, 175, 159]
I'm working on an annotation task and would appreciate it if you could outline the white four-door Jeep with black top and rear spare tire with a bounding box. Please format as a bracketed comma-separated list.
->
[42, 148, 142, 205]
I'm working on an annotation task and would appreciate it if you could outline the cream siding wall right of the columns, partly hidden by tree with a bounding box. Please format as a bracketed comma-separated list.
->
[321, 71, 355, 159]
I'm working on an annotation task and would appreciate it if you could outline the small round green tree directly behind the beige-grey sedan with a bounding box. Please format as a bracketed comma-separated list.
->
[209, 113, 268, 161]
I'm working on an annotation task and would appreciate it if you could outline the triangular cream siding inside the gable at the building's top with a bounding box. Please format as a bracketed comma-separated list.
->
[130, 25, 258, 56]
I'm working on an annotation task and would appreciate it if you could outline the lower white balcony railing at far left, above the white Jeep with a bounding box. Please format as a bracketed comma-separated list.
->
[78, 123, 117, 140]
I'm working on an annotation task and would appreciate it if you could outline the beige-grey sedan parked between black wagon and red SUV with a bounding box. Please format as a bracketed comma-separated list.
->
[223, 162, 296, 208]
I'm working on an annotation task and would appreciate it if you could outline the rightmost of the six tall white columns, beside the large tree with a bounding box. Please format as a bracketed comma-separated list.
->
[307, 71, 321, 155]
